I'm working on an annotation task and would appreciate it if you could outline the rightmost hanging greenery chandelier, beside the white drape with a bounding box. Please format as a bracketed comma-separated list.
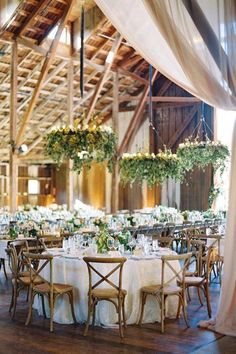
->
[177, 138, 229, 173]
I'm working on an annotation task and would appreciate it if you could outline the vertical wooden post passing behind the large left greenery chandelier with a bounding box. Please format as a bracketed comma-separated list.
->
[66, 59, 74, 210]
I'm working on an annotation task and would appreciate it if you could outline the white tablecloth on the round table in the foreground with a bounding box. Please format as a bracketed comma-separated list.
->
[34, 252, 179, 326]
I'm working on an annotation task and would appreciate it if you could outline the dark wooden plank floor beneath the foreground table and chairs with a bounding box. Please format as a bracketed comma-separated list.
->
[0, 272, 236, 354]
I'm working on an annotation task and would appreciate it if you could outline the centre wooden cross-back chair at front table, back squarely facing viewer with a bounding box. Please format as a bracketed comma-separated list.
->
[83, 257, 127, 338]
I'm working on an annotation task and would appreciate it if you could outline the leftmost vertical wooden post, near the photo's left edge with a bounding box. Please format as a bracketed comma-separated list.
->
[9, 41, 18, 213]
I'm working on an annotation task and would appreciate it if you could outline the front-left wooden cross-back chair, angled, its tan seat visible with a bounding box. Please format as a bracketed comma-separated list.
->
[24, 252, 76, 332]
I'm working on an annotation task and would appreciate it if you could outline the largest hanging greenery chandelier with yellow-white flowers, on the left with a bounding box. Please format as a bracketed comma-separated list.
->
[45, 125, 117, 173]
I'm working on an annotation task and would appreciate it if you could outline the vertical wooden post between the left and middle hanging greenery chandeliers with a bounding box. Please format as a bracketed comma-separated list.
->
[111, 71, 119, 213]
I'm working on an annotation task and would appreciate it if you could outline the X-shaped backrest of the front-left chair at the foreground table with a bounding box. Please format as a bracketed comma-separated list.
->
[23, 252, 53, 291]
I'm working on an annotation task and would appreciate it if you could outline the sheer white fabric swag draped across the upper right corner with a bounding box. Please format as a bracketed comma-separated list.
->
[96, 0, 236, 110]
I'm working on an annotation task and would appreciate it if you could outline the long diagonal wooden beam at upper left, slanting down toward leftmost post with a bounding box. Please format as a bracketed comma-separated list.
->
[16, 0, 75, 145]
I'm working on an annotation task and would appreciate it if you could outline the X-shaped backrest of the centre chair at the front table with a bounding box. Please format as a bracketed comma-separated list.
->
[83, 257, 127, 295]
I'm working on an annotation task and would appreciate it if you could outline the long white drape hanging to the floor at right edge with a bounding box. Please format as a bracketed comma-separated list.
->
[215, 123, 236, 336]
